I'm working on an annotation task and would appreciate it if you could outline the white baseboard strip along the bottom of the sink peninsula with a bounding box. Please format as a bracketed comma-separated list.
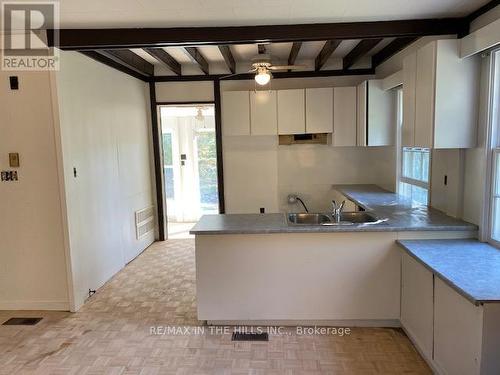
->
[207, 319, 401, 327]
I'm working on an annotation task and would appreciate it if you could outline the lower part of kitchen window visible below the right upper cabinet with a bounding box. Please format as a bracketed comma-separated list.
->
[399, 147, 430, 205]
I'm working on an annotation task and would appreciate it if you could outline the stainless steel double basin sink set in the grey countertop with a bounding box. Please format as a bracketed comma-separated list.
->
[287, 211, 383, 225]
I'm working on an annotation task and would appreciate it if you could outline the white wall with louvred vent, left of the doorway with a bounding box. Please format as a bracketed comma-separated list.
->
[57, 52, 154, 309]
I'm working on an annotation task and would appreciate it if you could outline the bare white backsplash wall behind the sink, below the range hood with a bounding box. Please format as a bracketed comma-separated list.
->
[278, 145, 396, 212]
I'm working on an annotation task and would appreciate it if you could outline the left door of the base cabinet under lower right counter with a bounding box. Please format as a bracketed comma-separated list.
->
[401, 253, 434, 360]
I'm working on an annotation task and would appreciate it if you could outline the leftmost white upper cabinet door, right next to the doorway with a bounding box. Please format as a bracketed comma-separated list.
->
[222, 91, 250, 135]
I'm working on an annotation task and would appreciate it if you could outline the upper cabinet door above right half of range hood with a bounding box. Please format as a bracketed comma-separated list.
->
[306, 88, 333, 133]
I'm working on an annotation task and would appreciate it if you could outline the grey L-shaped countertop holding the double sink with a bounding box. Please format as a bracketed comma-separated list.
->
[190, 185, 477, 235]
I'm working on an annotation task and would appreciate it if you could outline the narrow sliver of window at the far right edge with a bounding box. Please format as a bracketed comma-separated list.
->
[489, 50, 500, 245]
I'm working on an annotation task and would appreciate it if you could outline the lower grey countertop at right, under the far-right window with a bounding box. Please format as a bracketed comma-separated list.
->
[397, 240, 500, 305]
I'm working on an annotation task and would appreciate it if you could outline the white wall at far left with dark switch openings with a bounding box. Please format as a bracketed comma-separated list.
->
[0, 70, 69, 310]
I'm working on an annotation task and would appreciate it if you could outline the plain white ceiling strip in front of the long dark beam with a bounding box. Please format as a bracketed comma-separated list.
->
[60, 0, 488, 28]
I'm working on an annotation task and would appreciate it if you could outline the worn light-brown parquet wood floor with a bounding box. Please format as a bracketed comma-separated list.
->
[0, 239, 431, 375]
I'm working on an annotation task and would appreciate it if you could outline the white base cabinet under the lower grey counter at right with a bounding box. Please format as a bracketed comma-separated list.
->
[401, 253, 500, 375]
